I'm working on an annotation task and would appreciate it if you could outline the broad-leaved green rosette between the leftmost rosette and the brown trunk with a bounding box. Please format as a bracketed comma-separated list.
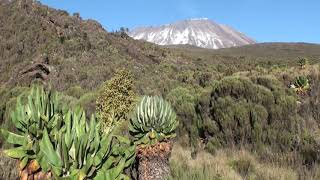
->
[37, 107, 135, 180]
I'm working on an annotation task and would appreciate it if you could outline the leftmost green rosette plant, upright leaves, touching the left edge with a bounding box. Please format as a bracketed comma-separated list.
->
[1, 86, 62, 176]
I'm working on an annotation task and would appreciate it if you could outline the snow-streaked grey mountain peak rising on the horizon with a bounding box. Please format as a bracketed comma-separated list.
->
[129, 18, 255, 49]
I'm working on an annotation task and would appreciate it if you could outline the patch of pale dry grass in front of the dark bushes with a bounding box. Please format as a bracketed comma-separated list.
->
[170, 144, 298, 180]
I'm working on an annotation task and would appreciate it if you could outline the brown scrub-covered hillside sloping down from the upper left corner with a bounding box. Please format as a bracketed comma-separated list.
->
[0, 0, 178, 90]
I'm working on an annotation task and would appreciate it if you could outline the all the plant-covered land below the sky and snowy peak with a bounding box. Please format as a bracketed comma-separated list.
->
[0, 0, 320, 180]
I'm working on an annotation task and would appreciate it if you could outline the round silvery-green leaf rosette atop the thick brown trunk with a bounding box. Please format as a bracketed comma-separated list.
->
[129, 96, 179, 144]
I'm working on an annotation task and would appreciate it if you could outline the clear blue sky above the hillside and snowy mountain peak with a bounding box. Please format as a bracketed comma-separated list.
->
[40, 0, 320, 43]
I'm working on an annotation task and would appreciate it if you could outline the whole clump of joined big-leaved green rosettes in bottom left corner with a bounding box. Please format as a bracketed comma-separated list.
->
[1, 87, 135, 179]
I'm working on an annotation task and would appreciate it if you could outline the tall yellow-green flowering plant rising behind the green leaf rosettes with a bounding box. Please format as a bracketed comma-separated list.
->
[97, 69, 135, 131]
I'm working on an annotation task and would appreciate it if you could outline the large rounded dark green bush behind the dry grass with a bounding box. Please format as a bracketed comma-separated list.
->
[198, 77, 303, 151]
